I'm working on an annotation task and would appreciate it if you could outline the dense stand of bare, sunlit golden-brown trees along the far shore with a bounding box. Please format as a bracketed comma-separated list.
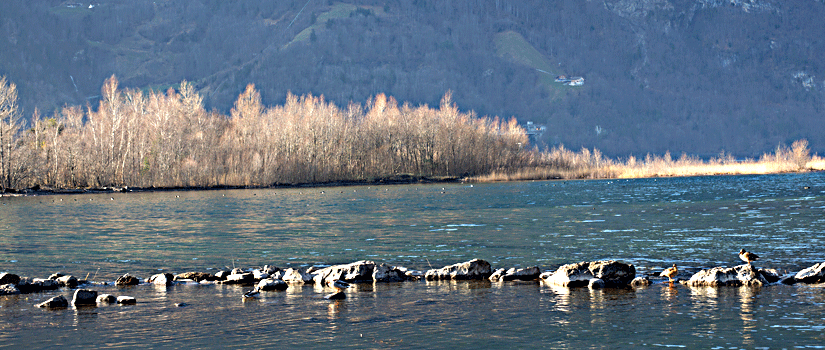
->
[0, 76, 531, 190]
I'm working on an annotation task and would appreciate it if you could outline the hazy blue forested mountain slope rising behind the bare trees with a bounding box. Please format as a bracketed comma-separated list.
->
[0, 0, 825, 156]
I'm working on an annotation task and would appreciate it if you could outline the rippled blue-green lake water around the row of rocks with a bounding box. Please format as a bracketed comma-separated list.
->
[0, 173, 825, 349]
